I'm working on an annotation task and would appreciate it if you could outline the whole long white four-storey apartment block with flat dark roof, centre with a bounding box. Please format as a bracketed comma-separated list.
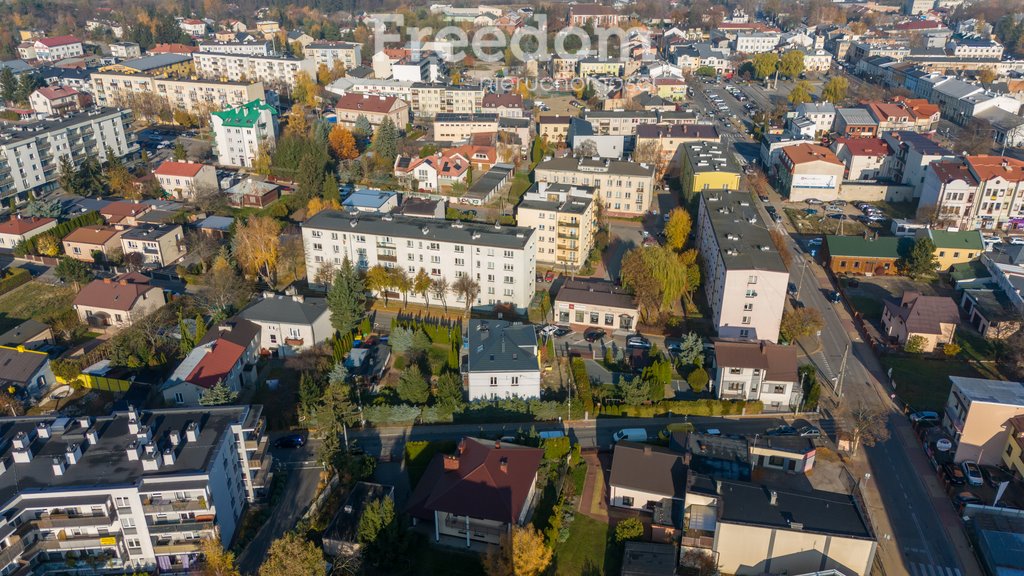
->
[302, 210, 537, 308]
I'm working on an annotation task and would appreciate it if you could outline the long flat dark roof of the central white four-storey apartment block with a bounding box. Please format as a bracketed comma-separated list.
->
[302, 210, 535, 249]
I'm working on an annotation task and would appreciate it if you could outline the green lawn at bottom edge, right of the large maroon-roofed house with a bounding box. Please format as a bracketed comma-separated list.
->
[553, 513, 623, 576]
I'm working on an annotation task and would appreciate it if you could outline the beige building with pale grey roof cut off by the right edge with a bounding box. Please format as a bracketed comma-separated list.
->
[937, 376, 1024, 466]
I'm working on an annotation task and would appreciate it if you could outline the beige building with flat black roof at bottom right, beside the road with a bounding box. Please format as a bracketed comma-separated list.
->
[681, 474, 878, 576]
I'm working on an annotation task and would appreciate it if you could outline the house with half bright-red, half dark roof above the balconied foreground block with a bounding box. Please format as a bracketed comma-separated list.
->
[161, 320, 260, 406]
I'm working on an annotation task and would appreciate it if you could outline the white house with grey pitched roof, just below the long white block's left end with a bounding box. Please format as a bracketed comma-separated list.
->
[239, 293, 334, 356]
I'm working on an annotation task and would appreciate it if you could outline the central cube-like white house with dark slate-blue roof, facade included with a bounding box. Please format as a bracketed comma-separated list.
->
[465, 320, 541, 401]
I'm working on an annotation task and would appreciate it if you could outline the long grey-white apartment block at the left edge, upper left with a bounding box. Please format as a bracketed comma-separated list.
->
[0, 109, 138, 200]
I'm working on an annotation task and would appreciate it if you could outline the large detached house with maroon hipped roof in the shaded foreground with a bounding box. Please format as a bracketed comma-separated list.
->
[408, 434, 544, 547]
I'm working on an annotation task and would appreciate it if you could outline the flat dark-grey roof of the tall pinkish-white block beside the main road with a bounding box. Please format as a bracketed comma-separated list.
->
[699, 190, 786, 272]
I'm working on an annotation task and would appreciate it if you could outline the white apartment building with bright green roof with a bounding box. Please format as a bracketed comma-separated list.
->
[210, 100, 278, 168]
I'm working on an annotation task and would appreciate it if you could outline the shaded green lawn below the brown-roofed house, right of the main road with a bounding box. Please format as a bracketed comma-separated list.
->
[882, 356, 979, 412]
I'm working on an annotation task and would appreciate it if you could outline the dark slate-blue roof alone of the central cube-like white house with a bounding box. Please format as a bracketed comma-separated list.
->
[468, 320, 540, 372]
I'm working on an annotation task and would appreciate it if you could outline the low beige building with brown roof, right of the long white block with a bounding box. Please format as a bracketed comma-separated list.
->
[554, 279, 640, 332]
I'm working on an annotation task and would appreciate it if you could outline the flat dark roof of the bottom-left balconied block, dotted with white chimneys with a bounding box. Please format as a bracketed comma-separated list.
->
[0, 406, 262, 503]
